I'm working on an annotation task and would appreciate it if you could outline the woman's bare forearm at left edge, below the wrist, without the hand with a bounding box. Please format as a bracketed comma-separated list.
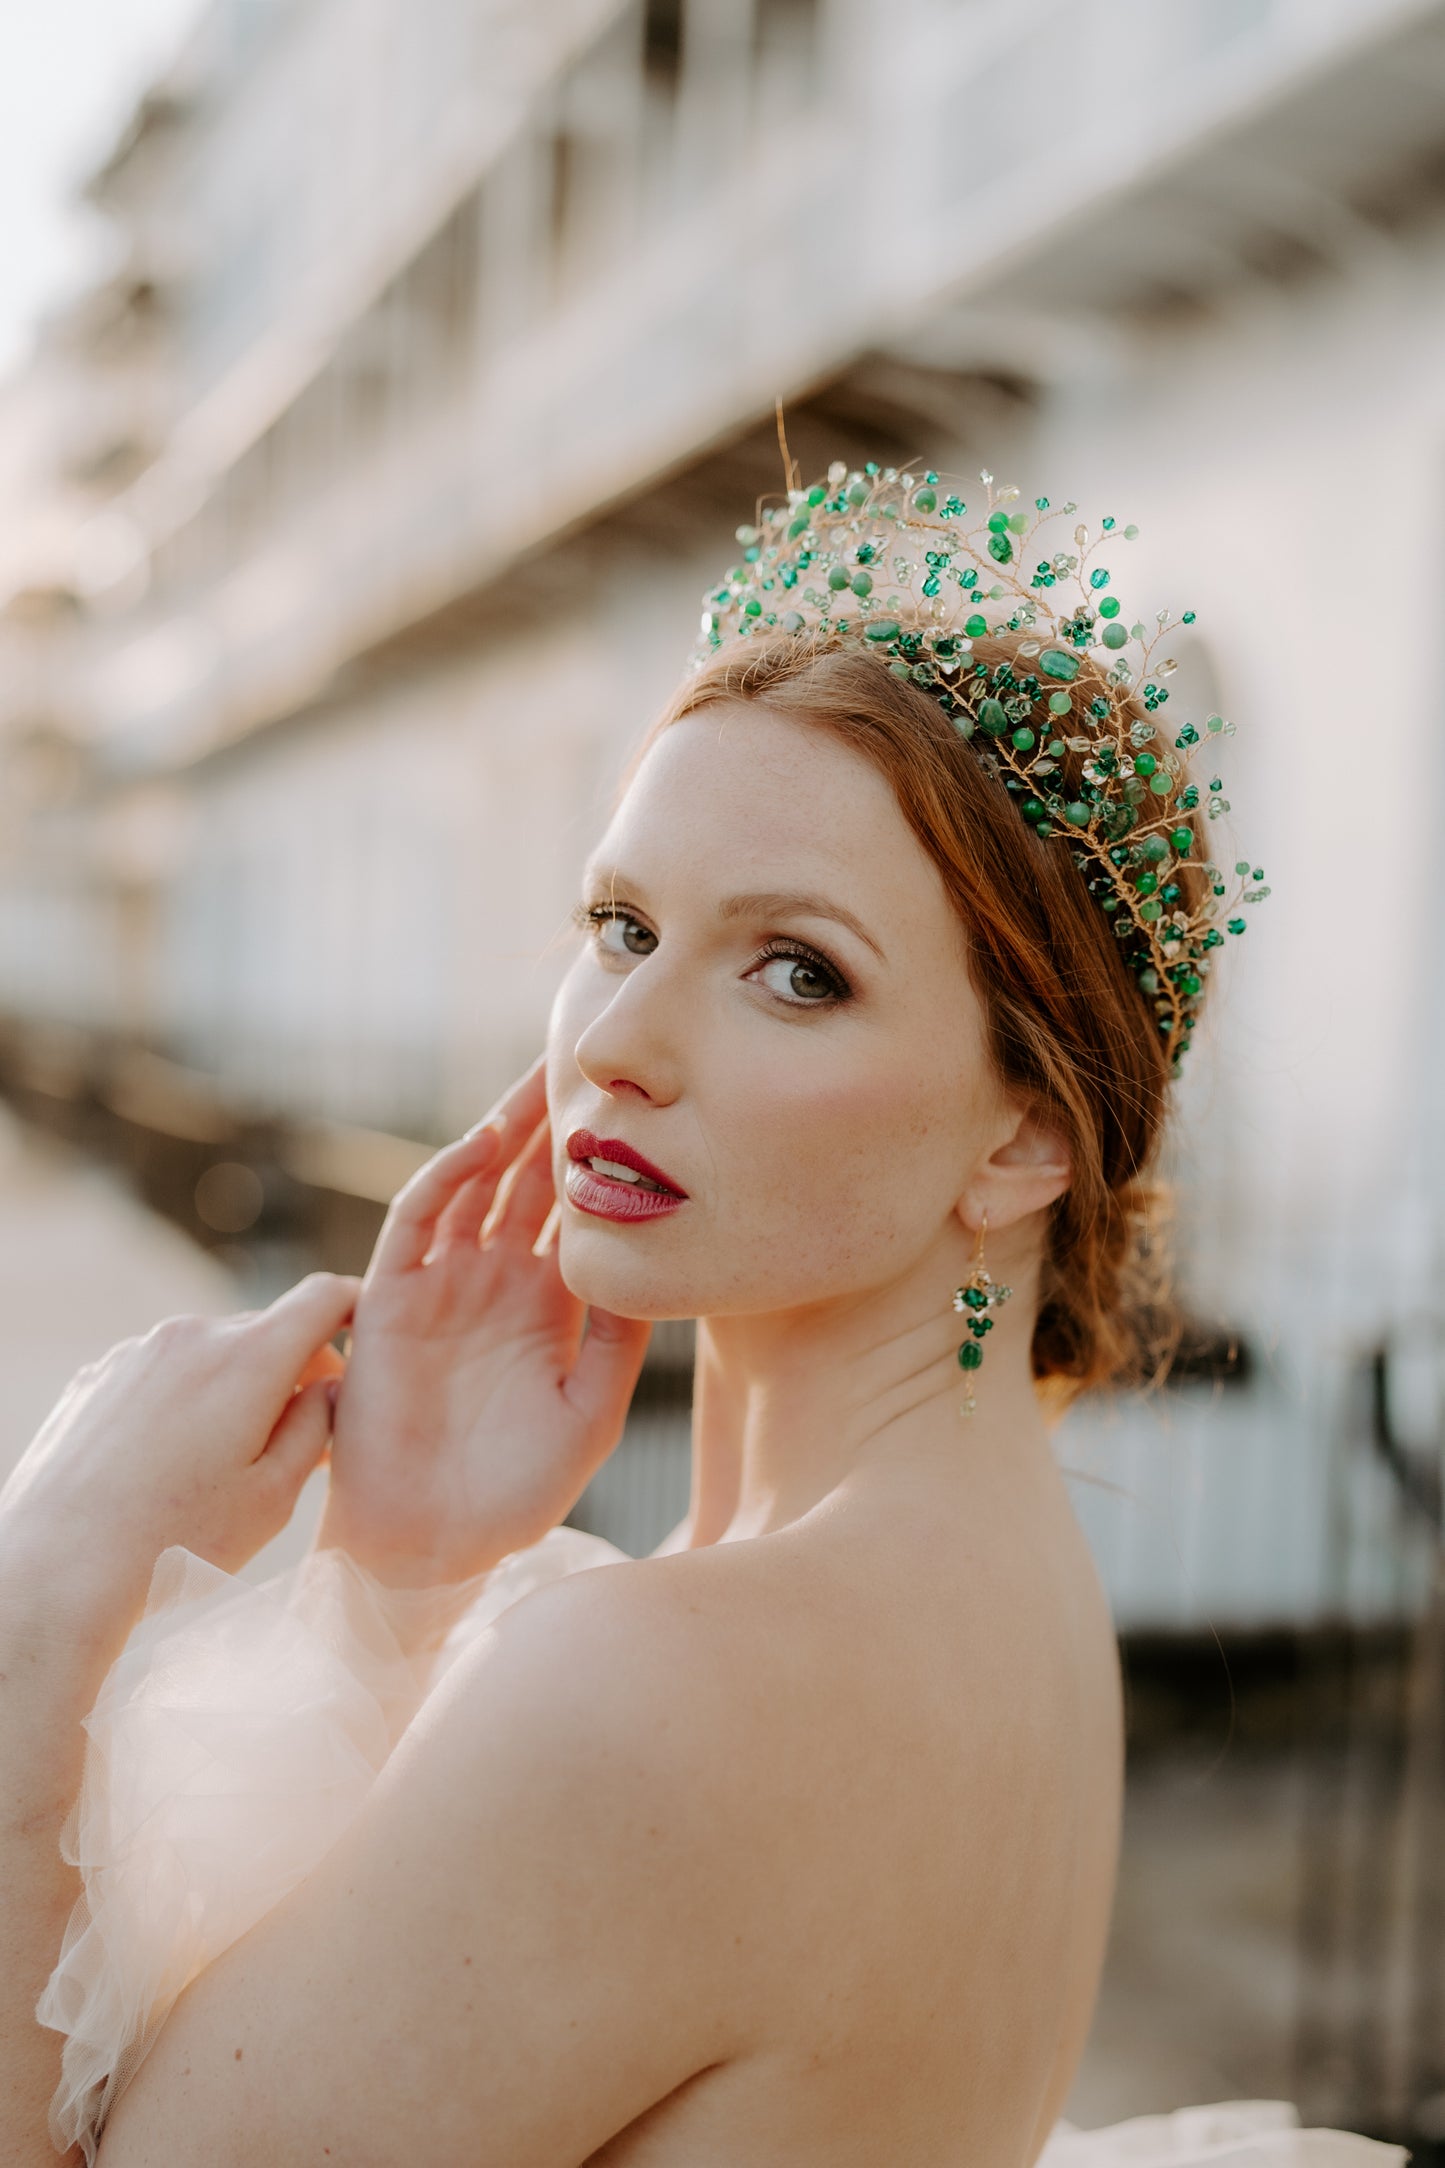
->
[0, 1546, 134, 2168]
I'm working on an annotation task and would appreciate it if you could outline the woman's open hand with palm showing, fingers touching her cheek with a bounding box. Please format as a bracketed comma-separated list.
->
[316, 1062, 650, 1585]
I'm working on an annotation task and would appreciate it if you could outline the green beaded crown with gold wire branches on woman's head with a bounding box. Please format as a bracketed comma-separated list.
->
[691, 462, 1270, 1073]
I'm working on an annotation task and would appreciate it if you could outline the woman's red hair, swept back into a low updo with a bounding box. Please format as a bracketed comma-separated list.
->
[639, 635, 1198, 1409]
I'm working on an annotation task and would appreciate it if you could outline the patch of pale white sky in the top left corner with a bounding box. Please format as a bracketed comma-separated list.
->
[0, 0, 206, 375]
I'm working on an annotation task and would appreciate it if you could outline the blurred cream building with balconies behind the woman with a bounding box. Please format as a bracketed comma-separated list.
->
[0, 0, 1445, 1626]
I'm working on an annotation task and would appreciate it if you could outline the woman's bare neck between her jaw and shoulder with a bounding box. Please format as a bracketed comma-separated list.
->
[687, 1229, 1049, 1548]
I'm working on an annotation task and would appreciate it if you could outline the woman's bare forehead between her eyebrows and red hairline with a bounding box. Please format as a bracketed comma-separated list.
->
[591, 700, 947, 908]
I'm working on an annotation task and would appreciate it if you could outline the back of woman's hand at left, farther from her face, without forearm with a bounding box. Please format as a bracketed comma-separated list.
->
[0, 1273, 360, 1611]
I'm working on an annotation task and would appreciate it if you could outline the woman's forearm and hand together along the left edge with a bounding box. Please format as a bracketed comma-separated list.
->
[0, 1275, 355, 2168]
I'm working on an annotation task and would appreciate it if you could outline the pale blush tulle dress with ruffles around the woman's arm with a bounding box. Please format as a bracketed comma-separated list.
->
[35, 1528, 1410, 2168]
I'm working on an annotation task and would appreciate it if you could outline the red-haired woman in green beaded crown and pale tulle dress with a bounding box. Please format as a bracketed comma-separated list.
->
[0, 468, 1402, 2168]
